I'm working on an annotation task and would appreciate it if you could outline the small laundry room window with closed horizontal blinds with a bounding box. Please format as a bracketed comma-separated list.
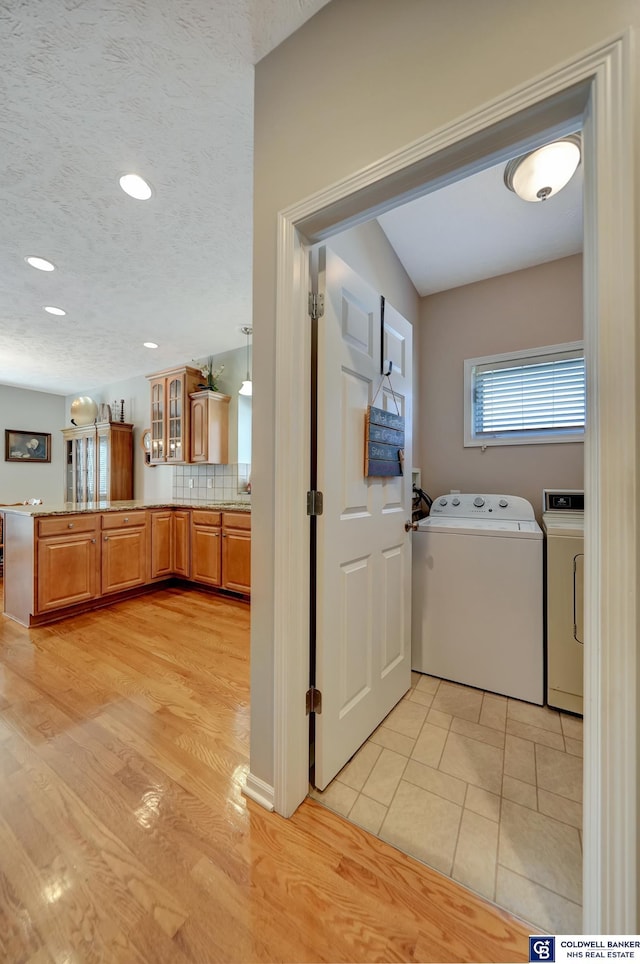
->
[465, 342, 586, 445]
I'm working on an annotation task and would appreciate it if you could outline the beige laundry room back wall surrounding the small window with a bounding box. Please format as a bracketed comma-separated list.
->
[416, 255, 583, 518]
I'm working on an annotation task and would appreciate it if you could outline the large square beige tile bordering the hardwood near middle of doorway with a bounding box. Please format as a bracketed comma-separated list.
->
[380, 780, 462, 874]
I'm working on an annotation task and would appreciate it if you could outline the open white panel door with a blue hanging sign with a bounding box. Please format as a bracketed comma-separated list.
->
[315, 248, 412, 789]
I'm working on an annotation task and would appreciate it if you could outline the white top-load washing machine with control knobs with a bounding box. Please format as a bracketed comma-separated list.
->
[412, 493, 544, 704]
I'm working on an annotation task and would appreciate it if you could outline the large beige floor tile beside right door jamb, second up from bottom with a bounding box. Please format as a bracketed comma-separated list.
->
[498, 800, 582, 903]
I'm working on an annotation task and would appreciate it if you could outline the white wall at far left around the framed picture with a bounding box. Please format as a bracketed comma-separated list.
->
[0, 385, 65, 505]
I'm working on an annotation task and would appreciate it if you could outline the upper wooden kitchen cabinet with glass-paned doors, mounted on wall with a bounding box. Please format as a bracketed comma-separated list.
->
[147, 365, 202, 465]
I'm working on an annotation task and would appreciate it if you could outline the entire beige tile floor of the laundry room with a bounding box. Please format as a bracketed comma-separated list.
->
[311, 673, 582, 934]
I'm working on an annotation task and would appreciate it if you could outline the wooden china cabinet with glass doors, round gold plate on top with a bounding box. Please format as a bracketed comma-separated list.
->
[62, 422, 133, 503]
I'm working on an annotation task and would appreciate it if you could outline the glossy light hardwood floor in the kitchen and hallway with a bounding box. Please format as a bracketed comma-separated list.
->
[0, 589, 528, 964]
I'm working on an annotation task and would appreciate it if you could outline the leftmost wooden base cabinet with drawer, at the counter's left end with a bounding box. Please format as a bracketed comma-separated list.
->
[35, 514, 99, 613]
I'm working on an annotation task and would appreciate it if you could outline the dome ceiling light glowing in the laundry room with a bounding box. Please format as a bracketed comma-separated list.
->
[504, 134, 582, 201]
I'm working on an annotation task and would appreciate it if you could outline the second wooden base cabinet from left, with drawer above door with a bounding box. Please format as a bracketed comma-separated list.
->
[101, 509, 150, 593]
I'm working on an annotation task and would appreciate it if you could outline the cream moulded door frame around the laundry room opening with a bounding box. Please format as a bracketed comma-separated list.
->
[274, 31, 638, 934]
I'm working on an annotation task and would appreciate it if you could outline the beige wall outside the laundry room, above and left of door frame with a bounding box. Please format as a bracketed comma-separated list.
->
[251, 0, 640, 783]
